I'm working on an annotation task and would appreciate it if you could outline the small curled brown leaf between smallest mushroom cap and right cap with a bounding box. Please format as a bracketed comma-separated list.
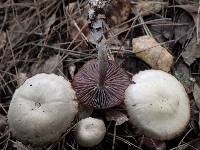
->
[105, 109, 128, 125]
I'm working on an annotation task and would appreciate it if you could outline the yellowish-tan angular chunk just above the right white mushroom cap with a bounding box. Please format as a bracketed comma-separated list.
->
[132, 36, 173, 72]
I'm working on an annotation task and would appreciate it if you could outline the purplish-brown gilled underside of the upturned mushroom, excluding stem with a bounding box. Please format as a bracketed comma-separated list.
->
[72, 60, 130, 109]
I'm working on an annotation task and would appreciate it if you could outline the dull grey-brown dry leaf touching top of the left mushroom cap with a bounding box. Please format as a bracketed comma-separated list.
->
[31, 55, 63, 75]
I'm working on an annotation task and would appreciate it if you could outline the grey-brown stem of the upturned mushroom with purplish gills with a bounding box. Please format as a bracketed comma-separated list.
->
[98, 49, 108, 88]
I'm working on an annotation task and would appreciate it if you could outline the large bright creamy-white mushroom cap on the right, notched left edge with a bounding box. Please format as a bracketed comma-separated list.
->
[125, 70, 190, 140]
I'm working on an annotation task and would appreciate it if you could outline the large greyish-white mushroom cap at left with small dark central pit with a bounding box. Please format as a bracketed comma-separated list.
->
[8, 73, 78, 145]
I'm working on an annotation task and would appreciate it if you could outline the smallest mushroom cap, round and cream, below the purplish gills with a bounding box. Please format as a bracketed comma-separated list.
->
[74, 117, 106, 147]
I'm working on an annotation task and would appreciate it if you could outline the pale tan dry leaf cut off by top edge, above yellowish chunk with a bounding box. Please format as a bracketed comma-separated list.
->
[132, 0, 167, 16]
